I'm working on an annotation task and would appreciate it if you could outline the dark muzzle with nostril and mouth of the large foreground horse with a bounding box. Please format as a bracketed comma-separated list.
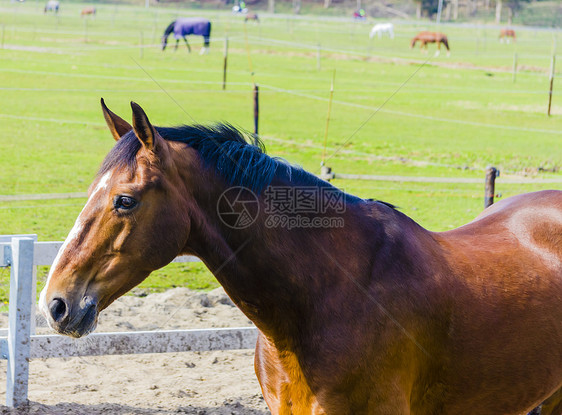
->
[43, 296, 98, 338]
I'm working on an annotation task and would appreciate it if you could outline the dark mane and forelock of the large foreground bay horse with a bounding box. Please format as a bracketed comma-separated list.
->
[98, 124, 331, 193]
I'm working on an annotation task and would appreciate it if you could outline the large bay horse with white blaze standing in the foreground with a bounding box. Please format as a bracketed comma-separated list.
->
[39, 99, 562, 415]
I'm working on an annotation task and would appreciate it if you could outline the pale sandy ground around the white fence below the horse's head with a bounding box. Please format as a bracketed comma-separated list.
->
[0, 288, 269, 415]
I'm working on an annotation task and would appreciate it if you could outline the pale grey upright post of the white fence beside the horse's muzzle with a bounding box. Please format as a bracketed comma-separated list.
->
[6, 238, 35, 407]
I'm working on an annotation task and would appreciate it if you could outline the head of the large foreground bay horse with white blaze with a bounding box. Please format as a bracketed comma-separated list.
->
[39, 99, 190, 337]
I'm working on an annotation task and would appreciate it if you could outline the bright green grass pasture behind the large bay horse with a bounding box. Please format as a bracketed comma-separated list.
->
[0, 1, 562, 302]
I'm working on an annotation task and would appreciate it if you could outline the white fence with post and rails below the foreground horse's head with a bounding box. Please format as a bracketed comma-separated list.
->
[0, 235, 257, 407]
